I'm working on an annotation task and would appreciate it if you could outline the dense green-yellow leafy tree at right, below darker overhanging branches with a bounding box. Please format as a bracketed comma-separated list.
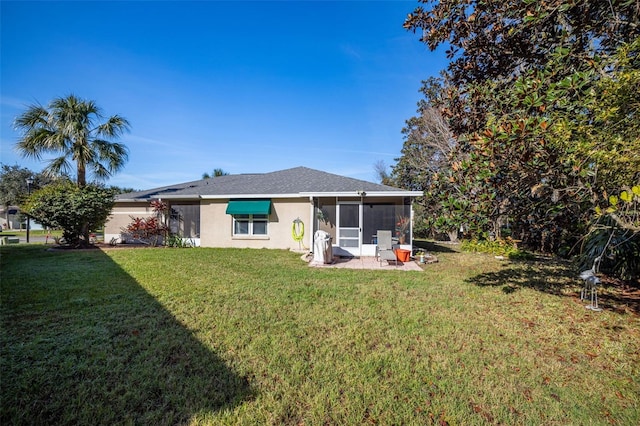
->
[454, 41, 640, 252]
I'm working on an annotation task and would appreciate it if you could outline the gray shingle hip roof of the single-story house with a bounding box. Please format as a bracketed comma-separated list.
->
[116, 167, 416, 200]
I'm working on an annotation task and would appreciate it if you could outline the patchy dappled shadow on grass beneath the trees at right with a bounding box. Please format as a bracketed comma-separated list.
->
[467, 255, 640, 315]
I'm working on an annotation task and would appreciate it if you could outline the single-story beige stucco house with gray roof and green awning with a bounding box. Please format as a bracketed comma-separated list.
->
[105, 167, 422, 256]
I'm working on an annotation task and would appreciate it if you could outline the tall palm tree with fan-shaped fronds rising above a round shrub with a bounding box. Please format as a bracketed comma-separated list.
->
[15, 95, 130, 187]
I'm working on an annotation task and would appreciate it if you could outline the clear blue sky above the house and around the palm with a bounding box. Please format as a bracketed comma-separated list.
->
[0, 1, 446, 189]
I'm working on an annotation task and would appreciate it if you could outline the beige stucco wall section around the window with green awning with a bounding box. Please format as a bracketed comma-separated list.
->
[200, 198, 313, 250]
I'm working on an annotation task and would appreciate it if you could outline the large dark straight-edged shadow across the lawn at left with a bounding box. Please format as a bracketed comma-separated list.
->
[0, 246, 253, 425]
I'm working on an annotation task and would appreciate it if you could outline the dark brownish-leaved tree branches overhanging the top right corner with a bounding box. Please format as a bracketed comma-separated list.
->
[404, 0, 640, 134]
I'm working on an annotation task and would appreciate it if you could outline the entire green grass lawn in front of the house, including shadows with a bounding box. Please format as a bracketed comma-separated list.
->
[0, 241, 640, 425]
